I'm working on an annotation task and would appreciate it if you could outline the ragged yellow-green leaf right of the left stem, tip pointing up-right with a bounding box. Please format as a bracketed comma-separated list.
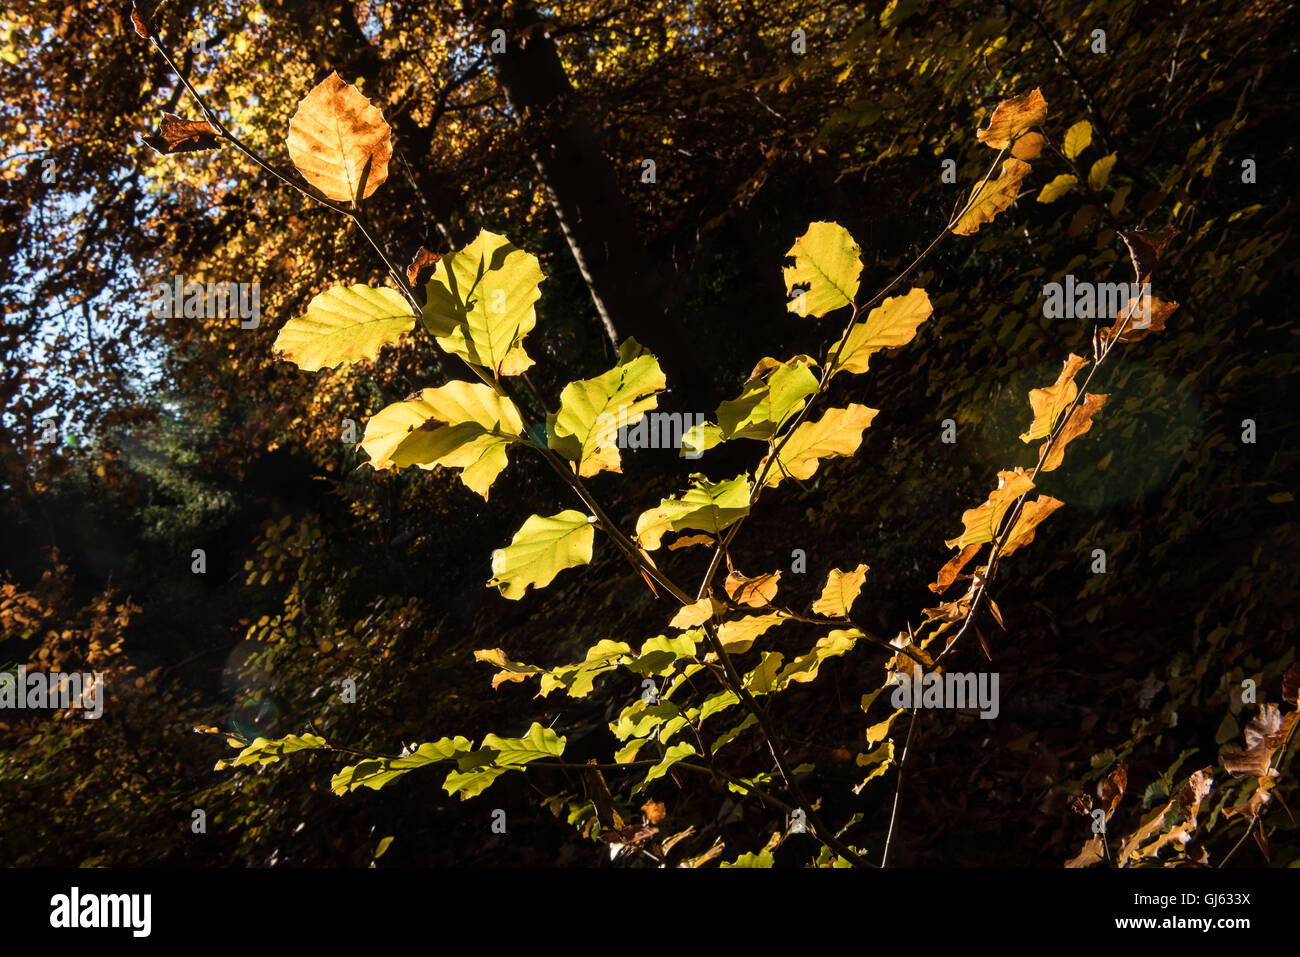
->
[547, 339, 667, 479]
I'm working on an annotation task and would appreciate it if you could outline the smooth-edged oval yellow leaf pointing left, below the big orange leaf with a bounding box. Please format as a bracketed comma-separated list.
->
[274, 285, 415, 372]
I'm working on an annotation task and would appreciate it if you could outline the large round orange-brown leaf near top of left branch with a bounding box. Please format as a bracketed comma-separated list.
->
[287, 73, 393, 202]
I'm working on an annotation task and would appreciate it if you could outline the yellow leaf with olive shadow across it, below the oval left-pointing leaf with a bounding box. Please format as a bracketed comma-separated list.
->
[361, 380, 524, 499]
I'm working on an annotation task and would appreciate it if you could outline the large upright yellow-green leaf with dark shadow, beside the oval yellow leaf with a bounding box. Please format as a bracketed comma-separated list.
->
[424, 229, 546, 376]
